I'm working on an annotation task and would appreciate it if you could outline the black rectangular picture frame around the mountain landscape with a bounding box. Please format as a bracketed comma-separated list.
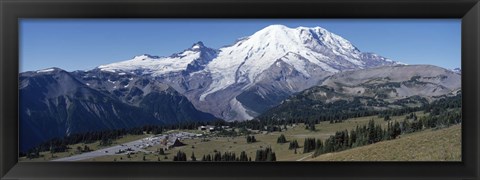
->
[0, 0, 480, 180]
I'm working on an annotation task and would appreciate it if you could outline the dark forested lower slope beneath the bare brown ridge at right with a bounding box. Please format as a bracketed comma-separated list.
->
[257, 92, 462, 123]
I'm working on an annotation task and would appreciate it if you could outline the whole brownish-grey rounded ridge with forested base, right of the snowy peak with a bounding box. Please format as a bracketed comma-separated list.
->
[258, 65, 461, 121]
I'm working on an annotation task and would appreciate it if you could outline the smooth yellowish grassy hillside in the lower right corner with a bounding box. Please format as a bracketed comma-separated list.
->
[306, 125, 462, 161]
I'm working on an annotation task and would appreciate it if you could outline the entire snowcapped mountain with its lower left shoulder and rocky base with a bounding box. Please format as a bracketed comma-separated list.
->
[98, 25, 401, 120]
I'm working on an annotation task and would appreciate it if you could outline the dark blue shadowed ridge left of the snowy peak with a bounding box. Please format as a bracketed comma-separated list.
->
[19, 68, 217, 152]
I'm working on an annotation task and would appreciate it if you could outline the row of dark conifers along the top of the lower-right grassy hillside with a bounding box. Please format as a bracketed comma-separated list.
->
[310, 105, 462, 157]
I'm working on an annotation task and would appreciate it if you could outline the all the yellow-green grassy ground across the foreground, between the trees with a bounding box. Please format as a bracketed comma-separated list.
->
[21, 112, 461, 161]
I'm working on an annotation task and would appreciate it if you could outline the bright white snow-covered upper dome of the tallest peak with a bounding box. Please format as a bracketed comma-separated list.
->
[200, 25, 402, 100]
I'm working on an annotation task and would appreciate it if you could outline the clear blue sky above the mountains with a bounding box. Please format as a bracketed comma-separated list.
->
[20, 19, 461, 72]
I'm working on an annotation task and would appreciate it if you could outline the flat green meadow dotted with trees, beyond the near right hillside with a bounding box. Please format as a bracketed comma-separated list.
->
[86, 112, 438, 161]
